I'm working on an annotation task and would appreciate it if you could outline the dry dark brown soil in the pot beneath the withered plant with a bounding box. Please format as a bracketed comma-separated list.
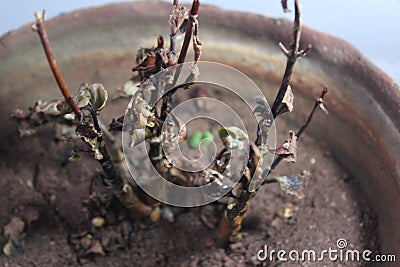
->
[0, 84, 379, 266]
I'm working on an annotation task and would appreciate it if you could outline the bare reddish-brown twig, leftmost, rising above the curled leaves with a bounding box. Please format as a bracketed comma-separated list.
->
[33, 10, 82, 120]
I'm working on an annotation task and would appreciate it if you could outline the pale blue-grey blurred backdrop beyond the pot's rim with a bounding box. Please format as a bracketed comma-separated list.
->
[0, 0, 400, 83]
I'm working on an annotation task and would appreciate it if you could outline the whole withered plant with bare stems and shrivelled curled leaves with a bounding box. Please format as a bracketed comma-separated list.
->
[11, 0, 327, 256]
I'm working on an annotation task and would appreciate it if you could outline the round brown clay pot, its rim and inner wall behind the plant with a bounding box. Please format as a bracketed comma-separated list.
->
[0, 2, 400, 264]
